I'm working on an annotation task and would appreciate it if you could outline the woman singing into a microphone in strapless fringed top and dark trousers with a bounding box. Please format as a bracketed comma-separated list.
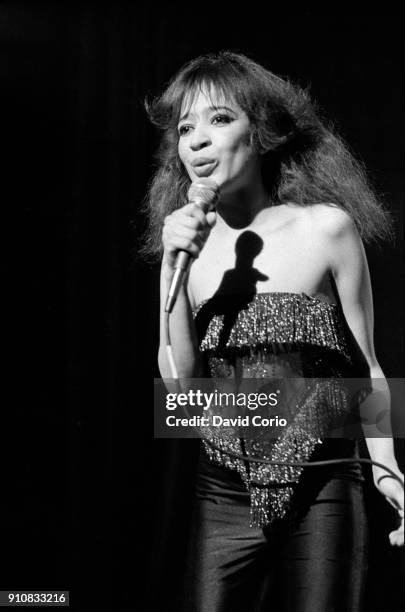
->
[140, 51, 404, 612]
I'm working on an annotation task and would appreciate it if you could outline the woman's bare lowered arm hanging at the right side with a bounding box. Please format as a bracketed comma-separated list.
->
[323, 208, 404, 544]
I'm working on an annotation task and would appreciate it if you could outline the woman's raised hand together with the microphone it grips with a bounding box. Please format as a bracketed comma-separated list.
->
[162, 178, 219, 312]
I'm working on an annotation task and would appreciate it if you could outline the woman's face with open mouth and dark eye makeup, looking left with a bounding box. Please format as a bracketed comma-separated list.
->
[178, 85, 259, 193]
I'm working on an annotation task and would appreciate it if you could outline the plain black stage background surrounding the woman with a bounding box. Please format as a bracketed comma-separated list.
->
[0, 3, 404, 612]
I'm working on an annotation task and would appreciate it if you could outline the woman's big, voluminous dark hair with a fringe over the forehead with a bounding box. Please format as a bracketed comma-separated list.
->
[141, 51, 392, 260]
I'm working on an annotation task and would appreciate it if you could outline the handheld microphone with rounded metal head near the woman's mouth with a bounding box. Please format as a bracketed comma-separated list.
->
[165, 177, 219, 313]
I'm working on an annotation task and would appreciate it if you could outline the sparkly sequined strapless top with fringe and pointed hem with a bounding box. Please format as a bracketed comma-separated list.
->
[194, 292, 360, 526]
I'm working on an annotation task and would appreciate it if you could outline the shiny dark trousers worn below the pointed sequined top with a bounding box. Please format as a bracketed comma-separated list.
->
[181, 444, 367, 612]
